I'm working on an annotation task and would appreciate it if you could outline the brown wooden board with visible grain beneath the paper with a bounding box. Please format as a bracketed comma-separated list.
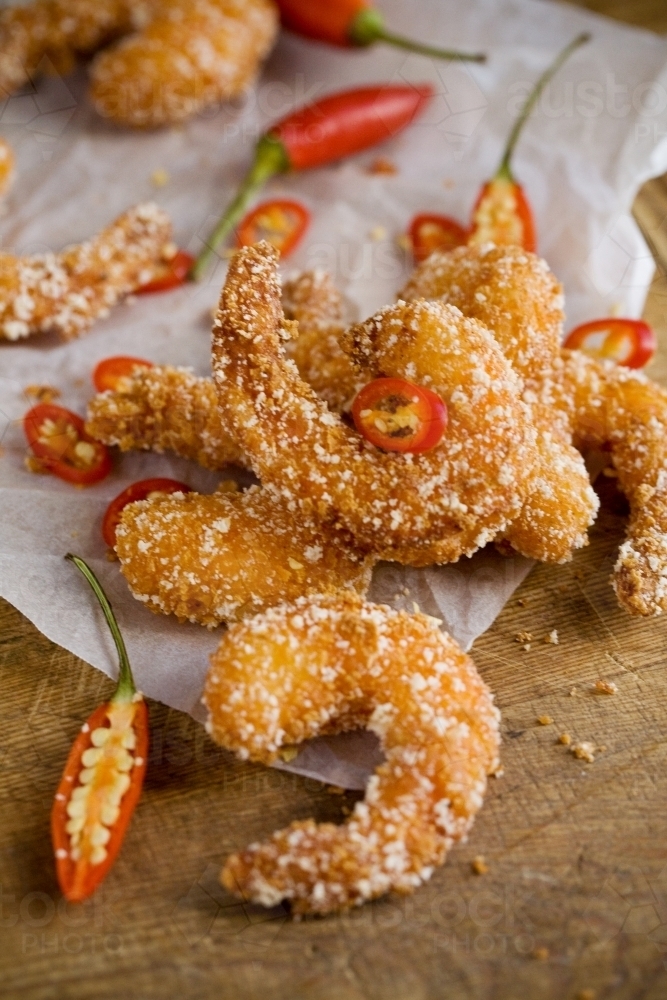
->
[0, 0, 667, 1000]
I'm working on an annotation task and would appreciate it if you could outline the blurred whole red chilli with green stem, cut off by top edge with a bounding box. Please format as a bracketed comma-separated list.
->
[278, 0, 486, 62]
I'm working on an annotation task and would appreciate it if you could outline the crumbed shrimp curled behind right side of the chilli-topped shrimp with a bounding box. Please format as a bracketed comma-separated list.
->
[403, 244, 599, 562]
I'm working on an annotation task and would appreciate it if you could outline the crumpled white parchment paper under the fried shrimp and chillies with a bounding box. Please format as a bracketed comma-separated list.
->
[0, 0, 667, 787]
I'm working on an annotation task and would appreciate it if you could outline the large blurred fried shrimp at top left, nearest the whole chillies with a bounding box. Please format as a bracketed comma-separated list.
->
[91, 0, 278, 128]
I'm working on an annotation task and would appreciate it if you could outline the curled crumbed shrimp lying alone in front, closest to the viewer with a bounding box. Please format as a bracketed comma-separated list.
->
[204, 595, 500, 914]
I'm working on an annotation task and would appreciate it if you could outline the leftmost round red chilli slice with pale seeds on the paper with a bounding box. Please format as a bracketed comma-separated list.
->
[23, 403, 111, 486]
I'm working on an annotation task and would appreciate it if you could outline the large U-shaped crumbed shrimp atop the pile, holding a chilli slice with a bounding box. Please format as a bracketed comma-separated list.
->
[213, 243, 536, 566]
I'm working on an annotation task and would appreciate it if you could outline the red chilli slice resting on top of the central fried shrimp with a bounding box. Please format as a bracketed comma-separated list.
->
[352, 378, 447, 452]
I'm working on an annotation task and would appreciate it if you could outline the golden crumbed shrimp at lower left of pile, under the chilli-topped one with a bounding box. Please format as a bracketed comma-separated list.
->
[116, 486, 372, 627]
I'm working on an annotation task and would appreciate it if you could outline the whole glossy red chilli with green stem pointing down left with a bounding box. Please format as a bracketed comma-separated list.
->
[190, 84, 433, 280]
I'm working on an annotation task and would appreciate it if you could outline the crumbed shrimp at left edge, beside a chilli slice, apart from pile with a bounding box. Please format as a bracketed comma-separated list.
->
[0, 203, 171, 340]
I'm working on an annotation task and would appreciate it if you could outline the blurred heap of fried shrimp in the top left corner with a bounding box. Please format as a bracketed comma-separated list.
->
[0, 0, 278, 127]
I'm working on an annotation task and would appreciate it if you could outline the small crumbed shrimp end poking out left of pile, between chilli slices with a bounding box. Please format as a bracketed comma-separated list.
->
[86, 365, 246, 469]
